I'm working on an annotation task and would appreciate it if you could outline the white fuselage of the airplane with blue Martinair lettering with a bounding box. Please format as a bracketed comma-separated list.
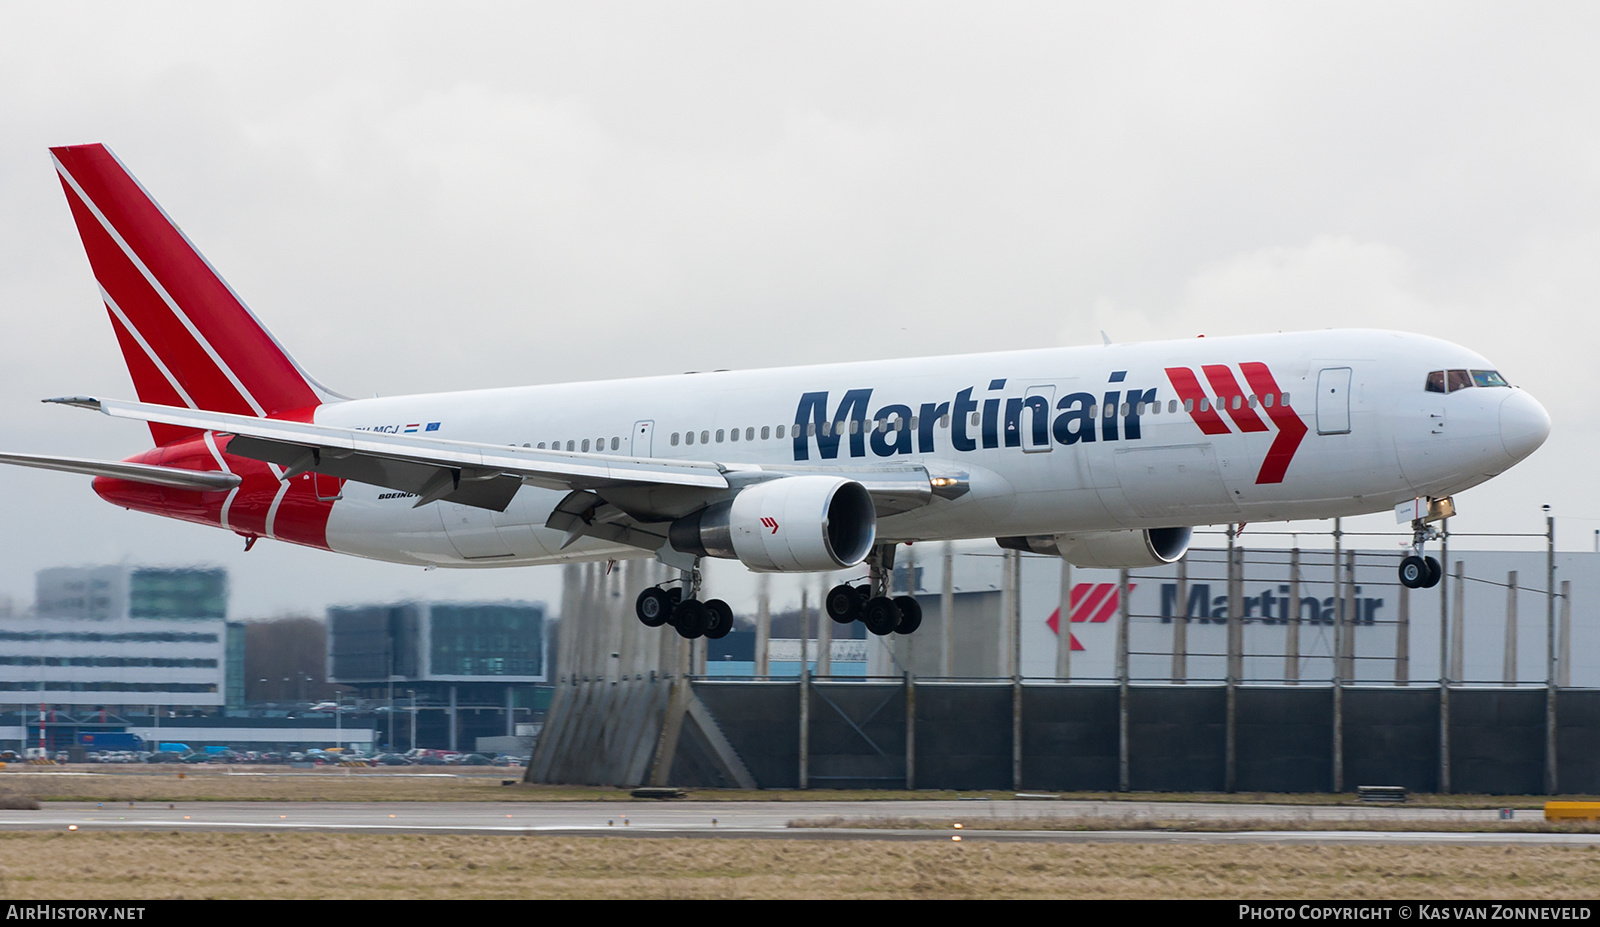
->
[315, 331, 1549, 567]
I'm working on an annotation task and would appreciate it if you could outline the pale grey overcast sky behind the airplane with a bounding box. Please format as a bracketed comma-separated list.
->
[0, 0, 1600, 616]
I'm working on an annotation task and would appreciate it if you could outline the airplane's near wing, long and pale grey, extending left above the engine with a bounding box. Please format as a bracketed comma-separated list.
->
[46, 397, 966, 524]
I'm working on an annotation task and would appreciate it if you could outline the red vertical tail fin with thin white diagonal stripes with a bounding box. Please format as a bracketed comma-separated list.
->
[50, 144, 338, 445]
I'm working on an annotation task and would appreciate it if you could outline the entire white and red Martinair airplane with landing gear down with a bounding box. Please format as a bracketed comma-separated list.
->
[0, 144, 1550, 637]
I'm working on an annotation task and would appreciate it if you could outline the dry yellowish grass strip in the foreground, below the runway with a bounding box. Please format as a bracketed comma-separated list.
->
[0, 831, 1600, 901]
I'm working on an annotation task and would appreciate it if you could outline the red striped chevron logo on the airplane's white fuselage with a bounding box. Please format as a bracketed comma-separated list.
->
[1166, 362, 1307, 484]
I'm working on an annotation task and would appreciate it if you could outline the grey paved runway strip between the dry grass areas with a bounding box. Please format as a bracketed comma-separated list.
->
[0, 801, 1600, 845]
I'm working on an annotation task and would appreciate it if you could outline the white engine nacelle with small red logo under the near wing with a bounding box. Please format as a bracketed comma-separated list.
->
[667, 476, 878, 573]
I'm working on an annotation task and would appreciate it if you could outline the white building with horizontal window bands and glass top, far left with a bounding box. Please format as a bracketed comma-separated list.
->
[0, 565, 373, 751]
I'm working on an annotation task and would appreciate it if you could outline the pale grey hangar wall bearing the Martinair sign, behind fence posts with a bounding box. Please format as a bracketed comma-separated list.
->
[953, 548, 1600, 687]
